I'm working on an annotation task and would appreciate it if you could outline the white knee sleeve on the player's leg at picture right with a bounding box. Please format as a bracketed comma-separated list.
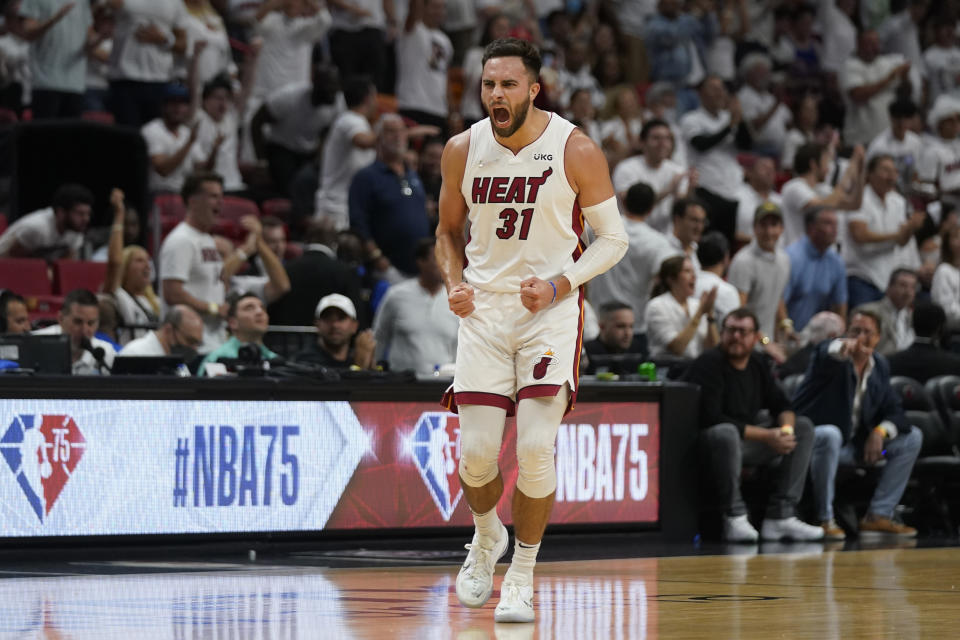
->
[517, 386, 570, 498]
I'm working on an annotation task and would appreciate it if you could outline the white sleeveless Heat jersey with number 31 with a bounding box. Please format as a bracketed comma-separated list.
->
[460, 114, 583, 293]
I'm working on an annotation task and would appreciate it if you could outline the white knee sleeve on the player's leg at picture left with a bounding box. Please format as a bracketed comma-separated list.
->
[458, 404, 507, 487]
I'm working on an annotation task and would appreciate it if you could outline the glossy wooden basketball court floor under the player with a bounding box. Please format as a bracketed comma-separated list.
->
[0, 545, 960, 640]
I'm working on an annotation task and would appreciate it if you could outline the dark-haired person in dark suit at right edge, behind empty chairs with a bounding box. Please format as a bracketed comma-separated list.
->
[890, 302, 960, 384]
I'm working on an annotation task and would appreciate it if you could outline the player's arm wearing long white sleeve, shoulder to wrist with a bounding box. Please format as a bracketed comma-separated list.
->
[557, 129, 627, 295]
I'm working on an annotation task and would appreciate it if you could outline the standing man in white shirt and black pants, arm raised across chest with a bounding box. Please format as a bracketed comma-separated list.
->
[680, 76, 749, 240]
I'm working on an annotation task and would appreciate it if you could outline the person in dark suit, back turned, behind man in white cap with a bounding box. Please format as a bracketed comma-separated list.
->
[269, 221, 369, 326]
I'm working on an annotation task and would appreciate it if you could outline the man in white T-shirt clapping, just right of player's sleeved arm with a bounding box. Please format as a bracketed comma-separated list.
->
[613, 120, 697, 232]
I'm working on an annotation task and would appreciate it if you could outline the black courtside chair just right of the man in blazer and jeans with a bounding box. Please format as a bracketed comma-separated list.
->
[890, 376, 960, 536]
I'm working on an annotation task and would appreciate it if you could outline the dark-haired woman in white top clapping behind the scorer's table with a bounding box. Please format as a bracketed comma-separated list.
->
[645, 256, 720, 358]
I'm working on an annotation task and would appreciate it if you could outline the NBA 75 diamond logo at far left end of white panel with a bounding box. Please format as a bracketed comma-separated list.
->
[0, 415, 87, 522]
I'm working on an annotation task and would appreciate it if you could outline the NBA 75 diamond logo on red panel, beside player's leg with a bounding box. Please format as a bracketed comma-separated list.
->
[410, 411, 463, 521]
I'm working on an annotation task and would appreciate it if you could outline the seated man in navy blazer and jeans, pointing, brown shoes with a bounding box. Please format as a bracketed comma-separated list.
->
[793, 307, 923, 540]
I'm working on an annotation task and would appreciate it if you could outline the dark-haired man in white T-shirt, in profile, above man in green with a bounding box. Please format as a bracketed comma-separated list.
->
[160, 173, 228, 353]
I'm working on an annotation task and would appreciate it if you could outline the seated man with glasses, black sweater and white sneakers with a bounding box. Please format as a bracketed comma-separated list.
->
[685, 307, 823, 543]
